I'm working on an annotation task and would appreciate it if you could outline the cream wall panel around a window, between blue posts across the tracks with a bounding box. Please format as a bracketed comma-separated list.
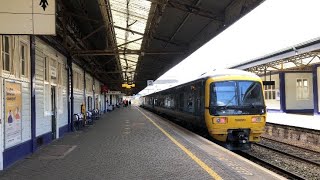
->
[285, 73, 314, 109]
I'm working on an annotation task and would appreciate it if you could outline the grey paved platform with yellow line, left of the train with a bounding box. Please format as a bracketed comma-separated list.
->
[0, 106, 283, 180]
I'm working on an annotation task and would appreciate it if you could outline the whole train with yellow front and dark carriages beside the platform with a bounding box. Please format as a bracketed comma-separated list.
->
[141, 69, 266, 150]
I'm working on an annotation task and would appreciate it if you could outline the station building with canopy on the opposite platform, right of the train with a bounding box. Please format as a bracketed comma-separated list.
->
[231, 39, 320, 116]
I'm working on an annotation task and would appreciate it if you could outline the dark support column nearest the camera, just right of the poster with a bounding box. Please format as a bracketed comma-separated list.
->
[30, 35, 37, 152]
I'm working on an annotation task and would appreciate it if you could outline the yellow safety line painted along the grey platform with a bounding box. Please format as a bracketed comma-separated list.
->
[137, 108, 222, 179]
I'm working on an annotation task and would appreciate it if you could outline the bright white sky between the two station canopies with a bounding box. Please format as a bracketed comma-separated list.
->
[140, 0, 320, 94]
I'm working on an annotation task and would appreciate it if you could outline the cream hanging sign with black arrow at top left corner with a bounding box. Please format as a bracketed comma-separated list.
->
[0, 0, 56, 35]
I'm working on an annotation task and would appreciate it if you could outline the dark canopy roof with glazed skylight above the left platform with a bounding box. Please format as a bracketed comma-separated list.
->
[50, 0, 263, 95]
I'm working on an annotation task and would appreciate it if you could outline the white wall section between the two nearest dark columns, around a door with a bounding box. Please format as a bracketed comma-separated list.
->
[36, 38, 68, 137]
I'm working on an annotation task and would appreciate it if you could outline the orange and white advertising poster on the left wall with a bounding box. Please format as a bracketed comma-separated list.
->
[5, 82, 22, 148]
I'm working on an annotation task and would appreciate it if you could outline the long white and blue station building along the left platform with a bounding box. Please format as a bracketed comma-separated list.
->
[0, 35, 121, 169]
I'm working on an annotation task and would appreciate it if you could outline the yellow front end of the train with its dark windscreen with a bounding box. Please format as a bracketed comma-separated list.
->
[205, 71, 266, 150]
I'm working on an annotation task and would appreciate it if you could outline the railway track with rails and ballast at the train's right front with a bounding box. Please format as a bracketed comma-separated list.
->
[238, 137, 320, 179]
